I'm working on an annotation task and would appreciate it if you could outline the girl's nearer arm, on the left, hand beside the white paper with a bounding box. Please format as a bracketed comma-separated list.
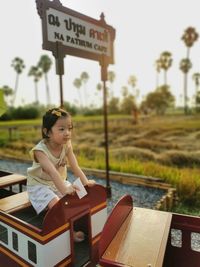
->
[34, 150, 77, 195]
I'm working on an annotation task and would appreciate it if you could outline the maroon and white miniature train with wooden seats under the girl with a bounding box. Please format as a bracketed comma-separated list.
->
[0, 171, 200, 267]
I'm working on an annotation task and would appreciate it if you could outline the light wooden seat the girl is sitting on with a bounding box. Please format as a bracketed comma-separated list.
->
[0, 191, 31, 213]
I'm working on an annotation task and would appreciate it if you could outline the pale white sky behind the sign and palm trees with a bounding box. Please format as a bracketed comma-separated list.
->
[0, 0, 200, 106]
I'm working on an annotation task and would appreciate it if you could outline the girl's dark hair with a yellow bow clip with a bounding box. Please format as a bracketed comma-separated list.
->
[42, 108, 71, 139]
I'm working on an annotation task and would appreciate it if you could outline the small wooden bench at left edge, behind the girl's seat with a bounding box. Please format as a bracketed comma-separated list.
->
[0, 173, 27, 192]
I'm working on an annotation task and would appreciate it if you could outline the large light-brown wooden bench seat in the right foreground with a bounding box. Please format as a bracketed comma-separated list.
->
[100, 208, 172, 267]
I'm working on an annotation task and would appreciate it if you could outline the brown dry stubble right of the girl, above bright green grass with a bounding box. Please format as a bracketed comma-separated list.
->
[73, 116, 200, 168]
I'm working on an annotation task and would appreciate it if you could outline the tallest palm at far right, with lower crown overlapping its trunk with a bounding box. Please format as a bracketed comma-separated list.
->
[181, 27, 199, 114]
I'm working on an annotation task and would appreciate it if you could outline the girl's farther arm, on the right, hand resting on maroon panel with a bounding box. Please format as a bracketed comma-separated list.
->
[67, 146, 95, 186]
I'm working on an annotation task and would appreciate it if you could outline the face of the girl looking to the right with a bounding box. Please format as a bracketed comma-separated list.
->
[49, 117, 73, 145]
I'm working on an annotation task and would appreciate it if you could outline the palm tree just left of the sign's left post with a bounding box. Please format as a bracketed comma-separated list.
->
[38, 55, 52, 105]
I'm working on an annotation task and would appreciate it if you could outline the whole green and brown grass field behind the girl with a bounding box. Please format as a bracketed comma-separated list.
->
[0, 115, 200, 215]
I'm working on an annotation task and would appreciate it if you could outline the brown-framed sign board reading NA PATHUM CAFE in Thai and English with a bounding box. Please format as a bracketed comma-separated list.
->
[36, 0, 115, 64]
